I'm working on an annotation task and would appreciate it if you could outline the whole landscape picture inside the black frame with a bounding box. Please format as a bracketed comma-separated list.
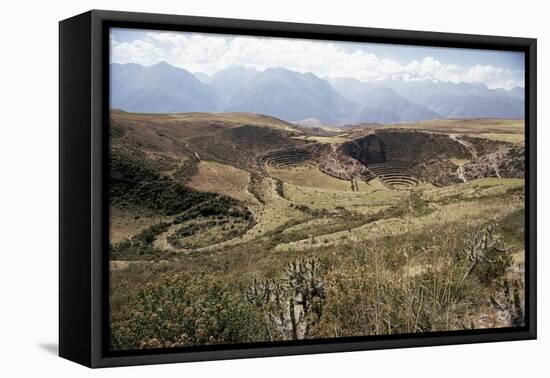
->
[103, 26, 528, 353]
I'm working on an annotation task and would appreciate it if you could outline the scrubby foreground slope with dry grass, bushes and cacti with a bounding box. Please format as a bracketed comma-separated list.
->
[111, 188, 524, 349]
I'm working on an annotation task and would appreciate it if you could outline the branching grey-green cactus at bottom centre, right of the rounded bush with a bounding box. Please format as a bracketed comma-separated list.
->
[245, 257, 325, 340]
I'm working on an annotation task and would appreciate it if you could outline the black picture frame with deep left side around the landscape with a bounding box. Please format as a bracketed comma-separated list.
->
[59, 10, 537, 367]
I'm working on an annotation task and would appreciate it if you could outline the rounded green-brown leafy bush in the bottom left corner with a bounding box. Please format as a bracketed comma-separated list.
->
[111, 274, 268, 350]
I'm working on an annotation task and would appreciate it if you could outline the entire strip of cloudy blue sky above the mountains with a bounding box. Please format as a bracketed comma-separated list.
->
[110, 28, 525, 90]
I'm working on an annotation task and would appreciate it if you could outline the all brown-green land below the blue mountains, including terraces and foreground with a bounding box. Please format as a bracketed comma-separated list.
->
[109, 110, 525, 350]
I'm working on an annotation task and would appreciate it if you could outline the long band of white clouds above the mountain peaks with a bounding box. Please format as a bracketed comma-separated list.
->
[111, 32, 523, 89]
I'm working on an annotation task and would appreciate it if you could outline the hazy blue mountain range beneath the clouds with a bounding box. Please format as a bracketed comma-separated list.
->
[110, 62, 524, 125]
